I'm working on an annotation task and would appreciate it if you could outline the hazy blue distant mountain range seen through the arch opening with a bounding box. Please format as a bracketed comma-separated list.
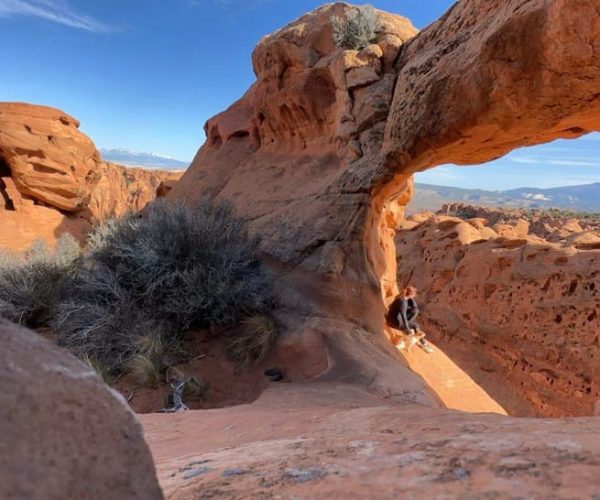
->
[408, 182, 600, 213]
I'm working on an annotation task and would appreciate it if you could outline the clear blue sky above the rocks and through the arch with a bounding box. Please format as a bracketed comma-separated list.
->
[0, 0, 600, 189]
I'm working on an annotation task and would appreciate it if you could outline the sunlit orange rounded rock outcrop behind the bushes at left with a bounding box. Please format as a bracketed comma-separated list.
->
[0, 103, 181, 249]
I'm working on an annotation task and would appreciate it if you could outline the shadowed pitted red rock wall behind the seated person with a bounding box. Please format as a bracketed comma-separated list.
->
[396, 207, 600, 417]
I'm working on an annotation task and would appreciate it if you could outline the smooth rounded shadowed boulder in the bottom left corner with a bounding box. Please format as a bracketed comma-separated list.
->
[0, 320, 163, 500]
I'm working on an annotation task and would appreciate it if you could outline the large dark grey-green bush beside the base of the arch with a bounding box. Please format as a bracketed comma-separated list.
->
[89, 200, 272, 330]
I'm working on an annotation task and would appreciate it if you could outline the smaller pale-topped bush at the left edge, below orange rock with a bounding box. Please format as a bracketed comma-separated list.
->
[0, 234, 81, 328]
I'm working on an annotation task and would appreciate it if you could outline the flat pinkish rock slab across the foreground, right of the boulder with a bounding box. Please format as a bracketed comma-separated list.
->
[141, 383, 600, 500]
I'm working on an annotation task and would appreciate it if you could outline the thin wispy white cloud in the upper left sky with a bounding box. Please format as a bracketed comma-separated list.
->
[0, 0, 109, 33]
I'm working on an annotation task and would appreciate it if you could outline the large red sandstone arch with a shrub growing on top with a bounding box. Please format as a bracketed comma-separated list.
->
[171, 0, 600, 400]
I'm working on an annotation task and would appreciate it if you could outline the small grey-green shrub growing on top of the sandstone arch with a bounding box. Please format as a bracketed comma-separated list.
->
[331, 5, 380, 50]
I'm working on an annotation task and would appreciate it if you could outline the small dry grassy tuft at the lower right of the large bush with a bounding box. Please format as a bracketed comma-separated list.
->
[223, 314, 277, 368]
